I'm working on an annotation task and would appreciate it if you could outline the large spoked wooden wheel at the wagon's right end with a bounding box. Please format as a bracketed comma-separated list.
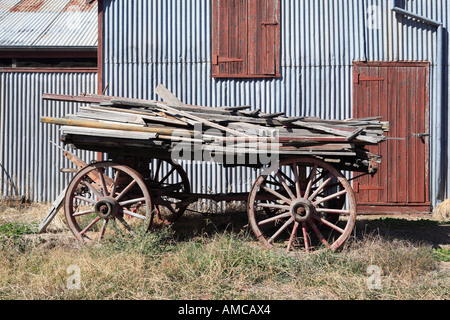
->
[247, 157, 356, 251]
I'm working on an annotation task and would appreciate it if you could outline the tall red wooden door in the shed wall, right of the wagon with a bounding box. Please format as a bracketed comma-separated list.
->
[353, 62, 431, 214]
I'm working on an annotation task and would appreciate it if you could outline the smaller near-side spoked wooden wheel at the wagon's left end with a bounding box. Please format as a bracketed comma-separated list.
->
[64, 162, 152, 243]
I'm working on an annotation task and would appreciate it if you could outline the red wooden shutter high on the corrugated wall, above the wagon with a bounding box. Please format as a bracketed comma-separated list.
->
[212, 0, 281, 78]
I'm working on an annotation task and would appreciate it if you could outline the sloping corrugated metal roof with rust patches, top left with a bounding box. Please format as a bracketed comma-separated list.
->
[0, 0, 98, 49]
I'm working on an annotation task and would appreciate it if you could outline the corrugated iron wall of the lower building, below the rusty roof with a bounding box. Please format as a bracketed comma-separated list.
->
[0, 72, 97, 202]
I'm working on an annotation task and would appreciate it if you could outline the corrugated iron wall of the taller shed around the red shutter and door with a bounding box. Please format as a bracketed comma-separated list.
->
[103, 0, 450, 208]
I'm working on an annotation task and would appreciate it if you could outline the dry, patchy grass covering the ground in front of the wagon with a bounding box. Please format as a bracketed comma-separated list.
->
[0, 205, 450, 300]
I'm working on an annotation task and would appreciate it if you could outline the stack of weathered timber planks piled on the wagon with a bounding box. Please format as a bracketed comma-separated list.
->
[41, 85, 389, 171]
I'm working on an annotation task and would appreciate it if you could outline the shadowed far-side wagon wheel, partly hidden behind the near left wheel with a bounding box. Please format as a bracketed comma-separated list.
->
[147, 159, 191, 223]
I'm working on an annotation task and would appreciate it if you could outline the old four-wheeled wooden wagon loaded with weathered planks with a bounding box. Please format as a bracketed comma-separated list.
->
[41, 86, 388, 251]
